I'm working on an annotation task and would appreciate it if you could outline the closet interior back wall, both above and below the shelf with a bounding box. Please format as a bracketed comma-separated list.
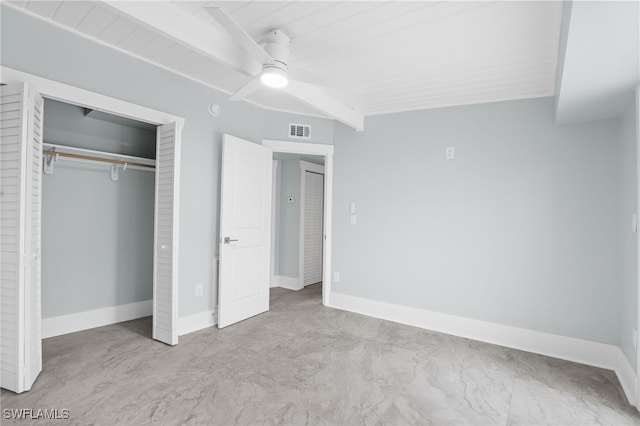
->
[42, 100, 156, 321]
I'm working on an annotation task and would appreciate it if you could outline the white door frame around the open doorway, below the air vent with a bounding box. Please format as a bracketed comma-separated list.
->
[262, 139, 334, 306]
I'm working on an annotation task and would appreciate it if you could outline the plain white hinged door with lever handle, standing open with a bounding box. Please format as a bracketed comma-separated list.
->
[218, 135, 273, 328]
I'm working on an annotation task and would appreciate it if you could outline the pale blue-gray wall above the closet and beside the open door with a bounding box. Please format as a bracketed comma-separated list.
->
[0, 6, 333, 316]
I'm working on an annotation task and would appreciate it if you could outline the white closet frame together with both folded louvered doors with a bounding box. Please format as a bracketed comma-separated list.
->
[0, 67, 184, 393]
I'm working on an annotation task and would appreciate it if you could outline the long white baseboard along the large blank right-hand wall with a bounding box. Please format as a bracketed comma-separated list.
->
[329, 292, 638, 406]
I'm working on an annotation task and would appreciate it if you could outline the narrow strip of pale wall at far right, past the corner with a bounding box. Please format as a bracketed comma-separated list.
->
[618, 100, 638, 367]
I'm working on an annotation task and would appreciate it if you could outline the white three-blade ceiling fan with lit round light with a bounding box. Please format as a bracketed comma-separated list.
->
[205, 7, 364, 131]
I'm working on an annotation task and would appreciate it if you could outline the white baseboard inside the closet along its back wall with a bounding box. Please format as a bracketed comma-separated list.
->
[42, 300, 153, 339]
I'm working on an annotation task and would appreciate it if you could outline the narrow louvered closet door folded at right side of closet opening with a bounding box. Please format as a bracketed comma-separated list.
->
[153, 123, 182, 345]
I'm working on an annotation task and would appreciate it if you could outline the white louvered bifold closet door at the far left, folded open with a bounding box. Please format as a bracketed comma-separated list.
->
[0, 84, 43, 392]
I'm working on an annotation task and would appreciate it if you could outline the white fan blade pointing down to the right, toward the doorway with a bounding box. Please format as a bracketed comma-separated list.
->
[280, 80, 364, 131]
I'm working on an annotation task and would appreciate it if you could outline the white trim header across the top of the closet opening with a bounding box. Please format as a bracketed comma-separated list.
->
[0, 66, 185, 344]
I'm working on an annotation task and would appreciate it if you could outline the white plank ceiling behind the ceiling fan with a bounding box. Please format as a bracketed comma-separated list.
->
[9, 1, 562, 121]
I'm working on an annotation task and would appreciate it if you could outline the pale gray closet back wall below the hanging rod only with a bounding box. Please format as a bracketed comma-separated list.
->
[42, 165, 154, 318]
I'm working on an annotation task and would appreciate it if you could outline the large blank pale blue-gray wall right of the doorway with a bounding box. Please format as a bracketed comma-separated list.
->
[332, 98, 621, 344]
